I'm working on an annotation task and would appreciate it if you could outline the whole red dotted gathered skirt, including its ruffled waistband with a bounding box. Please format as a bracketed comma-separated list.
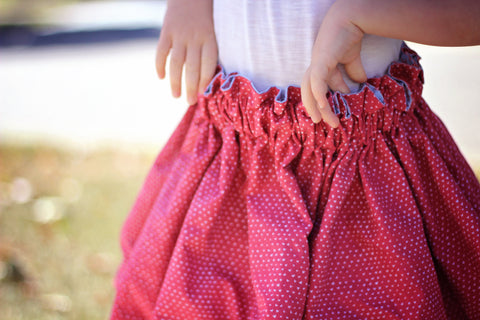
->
[111, 46, 480, 320]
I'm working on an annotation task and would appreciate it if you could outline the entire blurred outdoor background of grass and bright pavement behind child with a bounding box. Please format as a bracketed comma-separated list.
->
[0, 0, 480, 320]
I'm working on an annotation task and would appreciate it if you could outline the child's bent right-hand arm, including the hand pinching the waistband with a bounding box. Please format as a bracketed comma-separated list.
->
[302, 0, 480, 127]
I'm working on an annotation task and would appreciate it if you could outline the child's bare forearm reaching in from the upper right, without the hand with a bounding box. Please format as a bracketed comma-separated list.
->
[329, 0, 480, 46]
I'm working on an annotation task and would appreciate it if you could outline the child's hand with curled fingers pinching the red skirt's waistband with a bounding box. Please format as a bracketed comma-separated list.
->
[302, 2, 367, 128]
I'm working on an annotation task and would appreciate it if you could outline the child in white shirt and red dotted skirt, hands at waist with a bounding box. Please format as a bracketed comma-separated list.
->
[111, 0, 480, 320]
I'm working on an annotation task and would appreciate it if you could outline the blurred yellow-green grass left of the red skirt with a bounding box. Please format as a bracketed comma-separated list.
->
[0, 146, 154, 320]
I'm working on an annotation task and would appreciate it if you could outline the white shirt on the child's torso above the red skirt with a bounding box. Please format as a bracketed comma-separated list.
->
[214, 0, 402, 91]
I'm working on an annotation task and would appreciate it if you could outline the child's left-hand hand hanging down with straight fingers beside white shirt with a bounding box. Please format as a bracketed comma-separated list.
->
[156, 0, 218, 104]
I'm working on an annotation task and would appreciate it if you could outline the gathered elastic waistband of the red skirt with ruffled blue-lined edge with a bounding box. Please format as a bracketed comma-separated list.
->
[197, 44, 423, 149]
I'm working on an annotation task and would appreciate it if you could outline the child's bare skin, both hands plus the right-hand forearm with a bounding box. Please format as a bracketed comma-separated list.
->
[156, 0, 480, 128]
